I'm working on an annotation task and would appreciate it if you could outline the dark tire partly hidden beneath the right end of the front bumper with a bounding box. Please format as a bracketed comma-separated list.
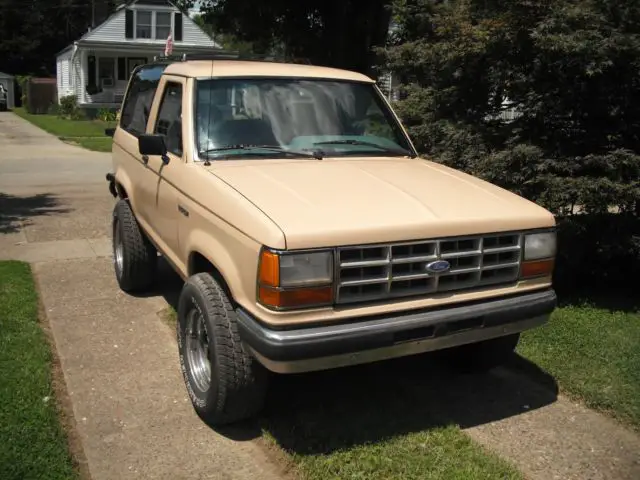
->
[444, 333, 520, 373]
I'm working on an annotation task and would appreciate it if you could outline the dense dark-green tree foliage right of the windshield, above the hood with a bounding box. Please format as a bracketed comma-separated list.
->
[382, 0, 640, 214]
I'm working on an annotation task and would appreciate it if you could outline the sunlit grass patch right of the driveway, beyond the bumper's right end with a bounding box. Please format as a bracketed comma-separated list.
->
[518, 304, 640, 429]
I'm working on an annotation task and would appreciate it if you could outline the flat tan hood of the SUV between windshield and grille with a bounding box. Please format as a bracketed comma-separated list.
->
[208, 158, 555, 249]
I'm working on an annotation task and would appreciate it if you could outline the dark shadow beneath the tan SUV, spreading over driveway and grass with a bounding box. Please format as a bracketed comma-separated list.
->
[148, 255, 558, 454]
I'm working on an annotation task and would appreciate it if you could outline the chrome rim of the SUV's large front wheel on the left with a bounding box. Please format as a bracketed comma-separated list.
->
[186, 308, 211, 392]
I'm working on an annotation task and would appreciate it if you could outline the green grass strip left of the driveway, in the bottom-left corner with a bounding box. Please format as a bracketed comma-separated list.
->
[0, 262, 77, 480]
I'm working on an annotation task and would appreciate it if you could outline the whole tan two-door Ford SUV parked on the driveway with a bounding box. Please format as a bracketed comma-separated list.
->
[107, 55, 556, 425]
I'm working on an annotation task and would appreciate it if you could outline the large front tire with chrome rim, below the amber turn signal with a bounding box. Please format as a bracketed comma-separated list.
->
[176, 273, 267, 426]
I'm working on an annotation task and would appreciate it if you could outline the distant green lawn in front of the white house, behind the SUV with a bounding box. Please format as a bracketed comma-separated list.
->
[13, 108, 115, 152]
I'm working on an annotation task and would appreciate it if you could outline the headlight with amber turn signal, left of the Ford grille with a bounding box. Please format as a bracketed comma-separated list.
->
[258, 249, 333, 310]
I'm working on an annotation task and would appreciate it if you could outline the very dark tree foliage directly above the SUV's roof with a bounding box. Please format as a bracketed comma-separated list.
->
[201, 0, 391, 72]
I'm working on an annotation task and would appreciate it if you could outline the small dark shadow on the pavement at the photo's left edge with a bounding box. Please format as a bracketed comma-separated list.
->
[0, 192, 70, 234]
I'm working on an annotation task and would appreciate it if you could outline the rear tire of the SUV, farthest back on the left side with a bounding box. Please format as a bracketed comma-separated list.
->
[112, 200, 158, 292]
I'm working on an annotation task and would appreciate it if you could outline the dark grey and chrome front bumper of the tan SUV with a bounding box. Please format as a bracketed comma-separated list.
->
[238, 289, 557, 373]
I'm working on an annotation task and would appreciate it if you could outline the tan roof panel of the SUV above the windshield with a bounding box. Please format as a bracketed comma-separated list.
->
[164, 60, 375, 83]
